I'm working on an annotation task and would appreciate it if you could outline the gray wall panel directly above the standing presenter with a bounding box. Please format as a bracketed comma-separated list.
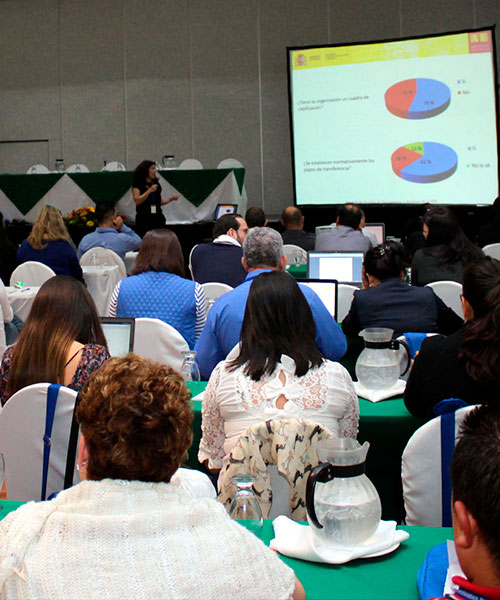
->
[124, 0, 192, 169]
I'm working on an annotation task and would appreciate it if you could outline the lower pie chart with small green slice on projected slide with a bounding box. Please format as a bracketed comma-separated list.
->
[391, 142, 458, 183]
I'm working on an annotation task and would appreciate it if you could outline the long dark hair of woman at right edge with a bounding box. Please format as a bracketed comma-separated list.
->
[459, 256, 500, 392]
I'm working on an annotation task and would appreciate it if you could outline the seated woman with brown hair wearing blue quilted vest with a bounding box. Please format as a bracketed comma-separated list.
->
[109, 229, 206, 348]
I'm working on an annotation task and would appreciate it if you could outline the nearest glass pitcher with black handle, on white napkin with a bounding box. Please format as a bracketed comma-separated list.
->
[306, 438, 382, 548]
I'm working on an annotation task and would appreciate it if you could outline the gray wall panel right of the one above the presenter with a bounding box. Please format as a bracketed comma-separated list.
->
[191, 0, 261, 206]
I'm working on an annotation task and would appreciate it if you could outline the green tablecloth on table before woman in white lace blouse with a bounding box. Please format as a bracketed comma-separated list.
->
[187, 382, 425, 521]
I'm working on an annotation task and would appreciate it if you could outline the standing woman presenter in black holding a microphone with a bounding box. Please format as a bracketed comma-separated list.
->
[132, 160, 179, 237]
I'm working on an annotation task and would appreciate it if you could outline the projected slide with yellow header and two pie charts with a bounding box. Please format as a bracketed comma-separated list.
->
[288, 29, 498, 205]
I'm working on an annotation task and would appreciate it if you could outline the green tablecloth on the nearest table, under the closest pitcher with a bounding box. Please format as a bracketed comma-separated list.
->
[0, 501, 453, 600]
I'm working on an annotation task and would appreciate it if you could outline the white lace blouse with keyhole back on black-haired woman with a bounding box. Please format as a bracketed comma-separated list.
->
[198, 355, 359, 469]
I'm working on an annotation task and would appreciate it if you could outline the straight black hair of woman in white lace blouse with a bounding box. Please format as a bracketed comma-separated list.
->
[230, 271, 323, 381]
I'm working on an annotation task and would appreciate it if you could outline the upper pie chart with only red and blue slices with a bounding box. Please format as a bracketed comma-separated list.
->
[384, 77, 451, 119]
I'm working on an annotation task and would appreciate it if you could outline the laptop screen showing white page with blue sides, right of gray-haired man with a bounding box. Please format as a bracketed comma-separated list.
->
[307, 251, 363, 287]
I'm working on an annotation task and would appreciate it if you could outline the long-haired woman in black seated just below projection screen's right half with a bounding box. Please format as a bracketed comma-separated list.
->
[411, 206, 483, 285]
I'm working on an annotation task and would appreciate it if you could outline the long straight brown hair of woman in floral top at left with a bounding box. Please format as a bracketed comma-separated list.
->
[3, 275, 107, 402]
